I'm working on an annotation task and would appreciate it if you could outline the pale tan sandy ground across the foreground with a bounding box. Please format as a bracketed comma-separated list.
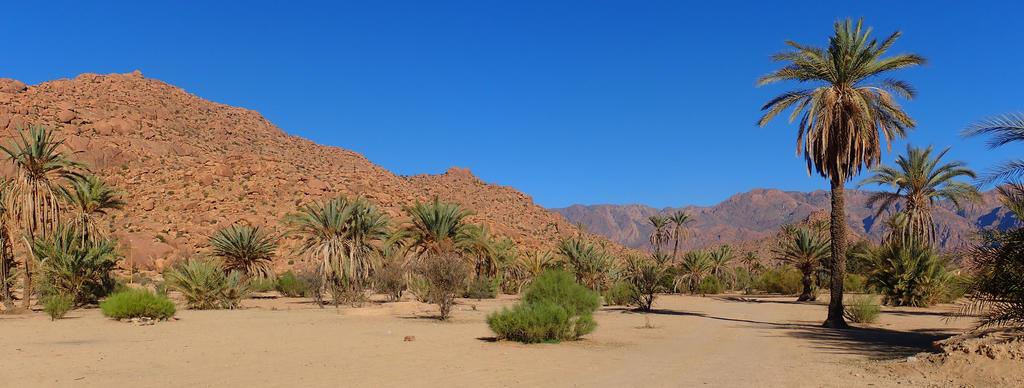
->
[0, 295, 1024, 387]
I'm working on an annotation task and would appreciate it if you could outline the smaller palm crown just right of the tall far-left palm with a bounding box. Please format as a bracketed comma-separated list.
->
[59, 175, 125, 240]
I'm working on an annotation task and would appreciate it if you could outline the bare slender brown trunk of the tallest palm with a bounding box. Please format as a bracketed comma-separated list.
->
[822, 177, 849, 329]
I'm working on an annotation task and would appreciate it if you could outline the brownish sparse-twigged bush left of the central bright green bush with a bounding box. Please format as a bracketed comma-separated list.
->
[420, 254, 469, 320]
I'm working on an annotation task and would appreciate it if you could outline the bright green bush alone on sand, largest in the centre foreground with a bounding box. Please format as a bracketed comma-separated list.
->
[487, 270, 600, 343]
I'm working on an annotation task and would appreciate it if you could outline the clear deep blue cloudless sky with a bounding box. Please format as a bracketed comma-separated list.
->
[0, 0, 1024, 207]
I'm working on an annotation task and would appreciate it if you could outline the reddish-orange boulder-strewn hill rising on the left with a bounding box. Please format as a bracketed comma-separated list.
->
[0, 72, 621, 269]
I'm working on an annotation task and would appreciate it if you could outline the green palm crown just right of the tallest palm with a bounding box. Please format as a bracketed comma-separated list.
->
[858, 145, 981, 243]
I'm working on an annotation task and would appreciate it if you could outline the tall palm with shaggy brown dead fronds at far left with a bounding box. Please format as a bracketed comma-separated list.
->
[0, 126, 84, 308]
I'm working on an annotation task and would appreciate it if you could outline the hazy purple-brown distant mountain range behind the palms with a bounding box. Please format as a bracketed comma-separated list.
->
[551, 188, 1018, 250]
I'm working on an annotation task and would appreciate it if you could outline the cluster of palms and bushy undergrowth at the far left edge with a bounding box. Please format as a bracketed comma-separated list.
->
[0, 126, 125, 308]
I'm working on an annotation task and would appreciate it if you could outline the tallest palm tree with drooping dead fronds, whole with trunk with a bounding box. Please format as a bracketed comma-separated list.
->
[758, 19, 925, 328]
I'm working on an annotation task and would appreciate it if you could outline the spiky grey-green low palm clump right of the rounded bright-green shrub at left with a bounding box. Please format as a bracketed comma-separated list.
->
[164, 260, 250, 310]
